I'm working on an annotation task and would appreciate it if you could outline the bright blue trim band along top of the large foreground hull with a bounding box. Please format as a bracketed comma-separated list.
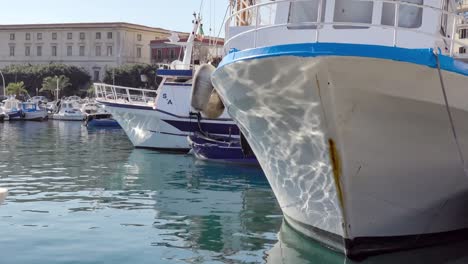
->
[218, 43, 468, 75]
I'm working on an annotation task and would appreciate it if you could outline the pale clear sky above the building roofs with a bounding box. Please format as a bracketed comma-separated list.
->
[0, 0, 229, 36]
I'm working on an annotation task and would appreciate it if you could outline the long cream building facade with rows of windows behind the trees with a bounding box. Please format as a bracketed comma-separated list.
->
[0, 23, 173, 81]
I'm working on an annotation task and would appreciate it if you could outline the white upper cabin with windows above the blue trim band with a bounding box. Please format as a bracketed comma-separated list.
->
[225, 0, 462, 54]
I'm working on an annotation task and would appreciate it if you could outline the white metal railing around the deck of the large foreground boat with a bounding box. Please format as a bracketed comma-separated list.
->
[224, 0, 465, 56]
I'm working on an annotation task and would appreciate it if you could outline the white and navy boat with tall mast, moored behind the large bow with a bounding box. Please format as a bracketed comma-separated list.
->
[94, 13, 239, 152]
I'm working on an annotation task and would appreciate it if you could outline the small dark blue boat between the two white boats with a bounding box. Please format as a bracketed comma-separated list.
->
[188, 133, 258, 165]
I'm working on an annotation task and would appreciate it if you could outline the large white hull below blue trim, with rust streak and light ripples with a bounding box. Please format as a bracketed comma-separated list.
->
[213, 45, 468, 255]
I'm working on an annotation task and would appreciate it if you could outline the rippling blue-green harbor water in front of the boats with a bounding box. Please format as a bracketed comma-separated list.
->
[0, 121, 468, 264]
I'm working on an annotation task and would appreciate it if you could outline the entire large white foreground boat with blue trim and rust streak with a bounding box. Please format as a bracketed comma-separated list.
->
[206, 0, 468, 257]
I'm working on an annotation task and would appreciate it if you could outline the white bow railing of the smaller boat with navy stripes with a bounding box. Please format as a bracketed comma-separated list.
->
[94, 83, 157, 105]
